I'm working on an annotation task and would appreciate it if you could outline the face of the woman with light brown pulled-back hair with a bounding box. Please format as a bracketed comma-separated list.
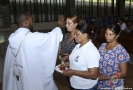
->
[66, 18, 77, 32]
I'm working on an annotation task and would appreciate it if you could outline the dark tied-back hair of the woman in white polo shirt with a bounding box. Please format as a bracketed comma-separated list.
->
[76, 23, 95, 39]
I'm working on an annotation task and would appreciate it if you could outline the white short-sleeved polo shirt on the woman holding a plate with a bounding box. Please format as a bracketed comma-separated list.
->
[69, 41, 100, 89]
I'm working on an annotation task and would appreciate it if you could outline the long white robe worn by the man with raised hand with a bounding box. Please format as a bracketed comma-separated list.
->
[3, 27, 63, 90]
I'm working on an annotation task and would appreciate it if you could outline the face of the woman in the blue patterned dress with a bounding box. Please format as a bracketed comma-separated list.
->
[105, 28, 117, 42]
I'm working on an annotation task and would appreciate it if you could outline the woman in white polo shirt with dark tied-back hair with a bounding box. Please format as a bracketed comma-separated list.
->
[63, 24, 100, 90]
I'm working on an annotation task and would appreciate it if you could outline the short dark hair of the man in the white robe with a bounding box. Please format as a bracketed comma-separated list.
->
[15, 11, 31, 27]
